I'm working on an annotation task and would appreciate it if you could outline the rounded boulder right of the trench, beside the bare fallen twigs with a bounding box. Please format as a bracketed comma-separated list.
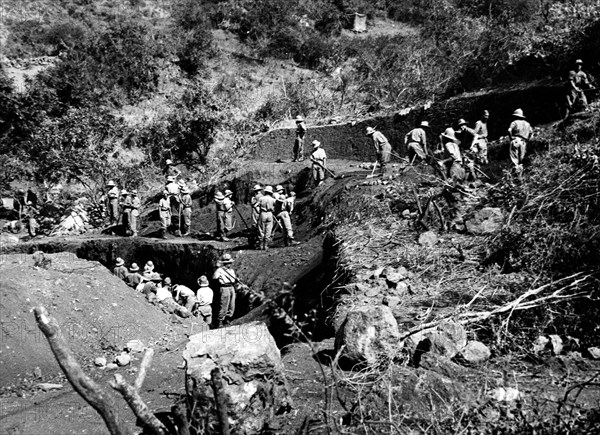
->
[335, 305, 401, 364]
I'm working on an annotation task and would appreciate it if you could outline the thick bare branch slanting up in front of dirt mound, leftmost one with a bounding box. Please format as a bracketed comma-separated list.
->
[34, 306, 129, 435]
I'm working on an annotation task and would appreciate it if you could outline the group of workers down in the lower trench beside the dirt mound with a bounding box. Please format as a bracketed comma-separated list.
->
[113, 253, 238, 328]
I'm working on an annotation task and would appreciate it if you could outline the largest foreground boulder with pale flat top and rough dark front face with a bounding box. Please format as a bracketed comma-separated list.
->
[183, 322, 291, 434]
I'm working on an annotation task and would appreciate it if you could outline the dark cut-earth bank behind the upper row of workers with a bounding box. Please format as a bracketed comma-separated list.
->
[252, 85, 564, 162]
